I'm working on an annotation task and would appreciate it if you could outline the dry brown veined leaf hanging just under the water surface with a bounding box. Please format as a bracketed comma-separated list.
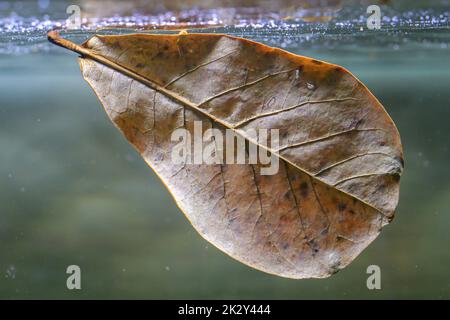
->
[49, 34, 403, 278]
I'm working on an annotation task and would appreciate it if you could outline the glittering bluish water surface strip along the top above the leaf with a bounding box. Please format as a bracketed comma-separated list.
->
[0, 1, 450, 55]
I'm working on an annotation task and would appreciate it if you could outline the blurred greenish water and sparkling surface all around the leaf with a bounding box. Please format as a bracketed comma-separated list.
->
[0, 0, 450, 299]
